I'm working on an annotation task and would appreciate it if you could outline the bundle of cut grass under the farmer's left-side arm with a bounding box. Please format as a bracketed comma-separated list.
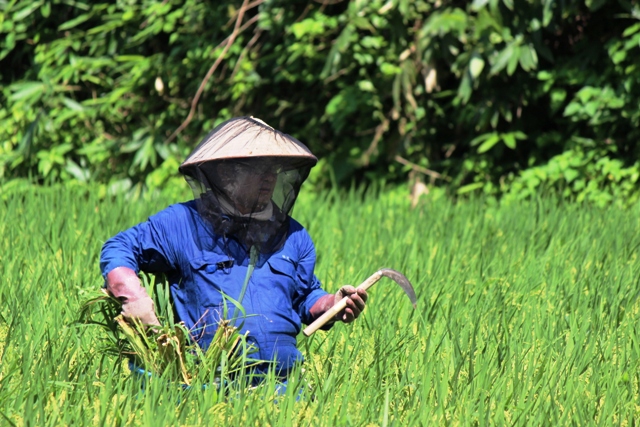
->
[79, 289, 260, 386]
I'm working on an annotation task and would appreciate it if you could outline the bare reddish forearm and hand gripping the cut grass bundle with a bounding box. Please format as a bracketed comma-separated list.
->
[107, 267, 160, 326]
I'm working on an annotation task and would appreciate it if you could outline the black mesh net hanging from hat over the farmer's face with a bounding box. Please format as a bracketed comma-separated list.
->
[184, 156, 313, 253]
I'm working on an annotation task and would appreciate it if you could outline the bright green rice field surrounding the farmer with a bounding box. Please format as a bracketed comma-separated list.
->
[0, 188, 640, 426]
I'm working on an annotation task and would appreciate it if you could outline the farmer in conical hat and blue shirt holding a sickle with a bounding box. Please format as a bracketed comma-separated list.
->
[100, 117, 367, 377]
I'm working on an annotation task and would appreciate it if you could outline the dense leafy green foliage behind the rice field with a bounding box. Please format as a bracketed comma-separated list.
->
[0, 0, 640, 204]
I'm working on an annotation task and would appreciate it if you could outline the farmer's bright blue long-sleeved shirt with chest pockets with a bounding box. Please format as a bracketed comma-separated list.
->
[100, 201, 327, 372]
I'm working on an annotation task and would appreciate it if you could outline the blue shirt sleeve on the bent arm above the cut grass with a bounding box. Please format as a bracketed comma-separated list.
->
[100, 207, 176, 278]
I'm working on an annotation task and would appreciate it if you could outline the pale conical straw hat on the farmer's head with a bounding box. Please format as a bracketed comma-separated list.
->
[180, 117, 318, 171]
